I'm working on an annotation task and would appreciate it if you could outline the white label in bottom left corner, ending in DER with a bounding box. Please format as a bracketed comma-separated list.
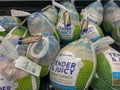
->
[0, 74, 18, 90]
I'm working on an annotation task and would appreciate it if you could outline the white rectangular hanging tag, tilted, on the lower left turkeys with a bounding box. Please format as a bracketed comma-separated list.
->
[15, 56, 41, 77]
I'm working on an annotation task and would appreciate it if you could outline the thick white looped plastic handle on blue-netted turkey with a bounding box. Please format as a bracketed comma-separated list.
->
[29, 37, 49, 59]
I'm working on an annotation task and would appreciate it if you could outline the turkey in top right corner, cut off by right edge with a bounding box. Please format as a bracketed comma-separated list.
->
[103, 0, 120, 46]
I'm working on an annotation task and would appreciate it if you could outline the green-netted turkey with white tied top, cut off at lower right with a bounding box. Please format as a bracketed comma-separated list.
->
[91, 38, 120, 90]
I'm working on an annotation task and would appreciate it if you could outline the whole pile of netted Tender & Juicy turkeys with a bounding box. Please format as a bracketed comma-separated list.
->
[0, 0, 120, 90]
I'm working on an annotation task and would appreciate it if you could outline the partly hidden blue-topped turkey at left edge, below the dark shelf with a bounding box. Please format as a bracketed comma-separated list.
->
[0, 16, 21, 32]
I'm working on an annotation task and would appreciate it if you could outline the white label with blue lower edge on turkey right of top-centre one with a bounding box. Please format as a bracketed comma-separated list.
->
[81, 25, 100, 41]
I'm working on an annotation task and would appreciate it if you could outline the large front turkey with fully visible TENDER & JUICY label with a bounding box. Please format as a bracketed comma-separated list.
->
[50, 39, 96, 90]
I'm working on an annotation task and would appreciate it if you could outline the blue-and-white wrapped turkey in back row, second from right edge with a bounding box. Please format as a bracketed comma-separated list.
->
[80, 0, 103, 25]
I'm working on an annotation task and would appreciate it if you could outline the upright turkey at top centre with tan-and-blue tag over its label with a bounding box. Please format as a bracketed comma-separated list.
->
[53, 1, 80, 43]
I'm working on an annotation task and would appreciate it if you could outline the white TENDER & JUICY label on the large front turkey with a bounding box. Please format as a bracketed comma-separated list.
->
[50, 51, 83, 90]
